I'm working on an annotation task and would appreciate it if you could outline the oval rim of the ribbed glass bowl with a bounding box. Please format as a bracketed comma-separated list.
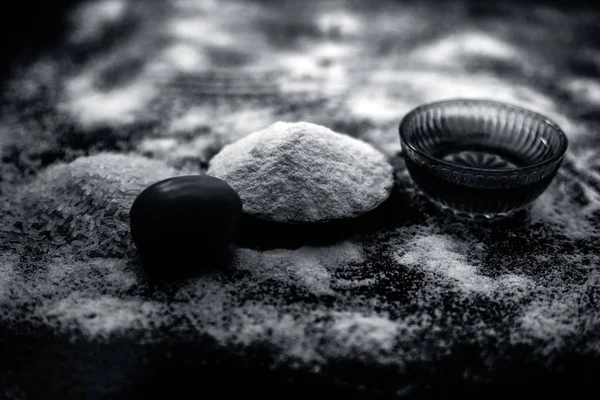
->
[398, 98, 568, 174]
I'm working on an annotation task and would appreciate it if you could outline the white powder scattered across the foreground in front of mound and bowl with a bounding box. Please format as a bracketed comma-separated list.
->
[0, 172, 600, 382]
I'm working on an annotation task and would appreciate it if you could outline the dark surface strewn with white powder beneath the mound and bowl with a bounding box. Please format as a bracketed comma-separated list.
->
[0, 0, 600, 399]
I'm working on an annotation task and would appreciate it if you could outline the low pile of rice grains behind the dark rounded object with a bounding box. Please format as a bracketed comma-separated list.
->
[3, 153, 177, 257]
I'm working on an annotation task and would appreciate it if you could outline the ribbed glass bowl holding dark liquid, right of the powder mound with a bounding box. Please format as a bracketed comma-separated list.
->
[399, 99, 567, 219]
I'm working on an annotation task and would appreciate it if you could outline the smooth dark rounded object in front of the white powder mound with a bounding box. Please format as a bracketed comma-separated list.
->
[129, 175, 242, 275]
